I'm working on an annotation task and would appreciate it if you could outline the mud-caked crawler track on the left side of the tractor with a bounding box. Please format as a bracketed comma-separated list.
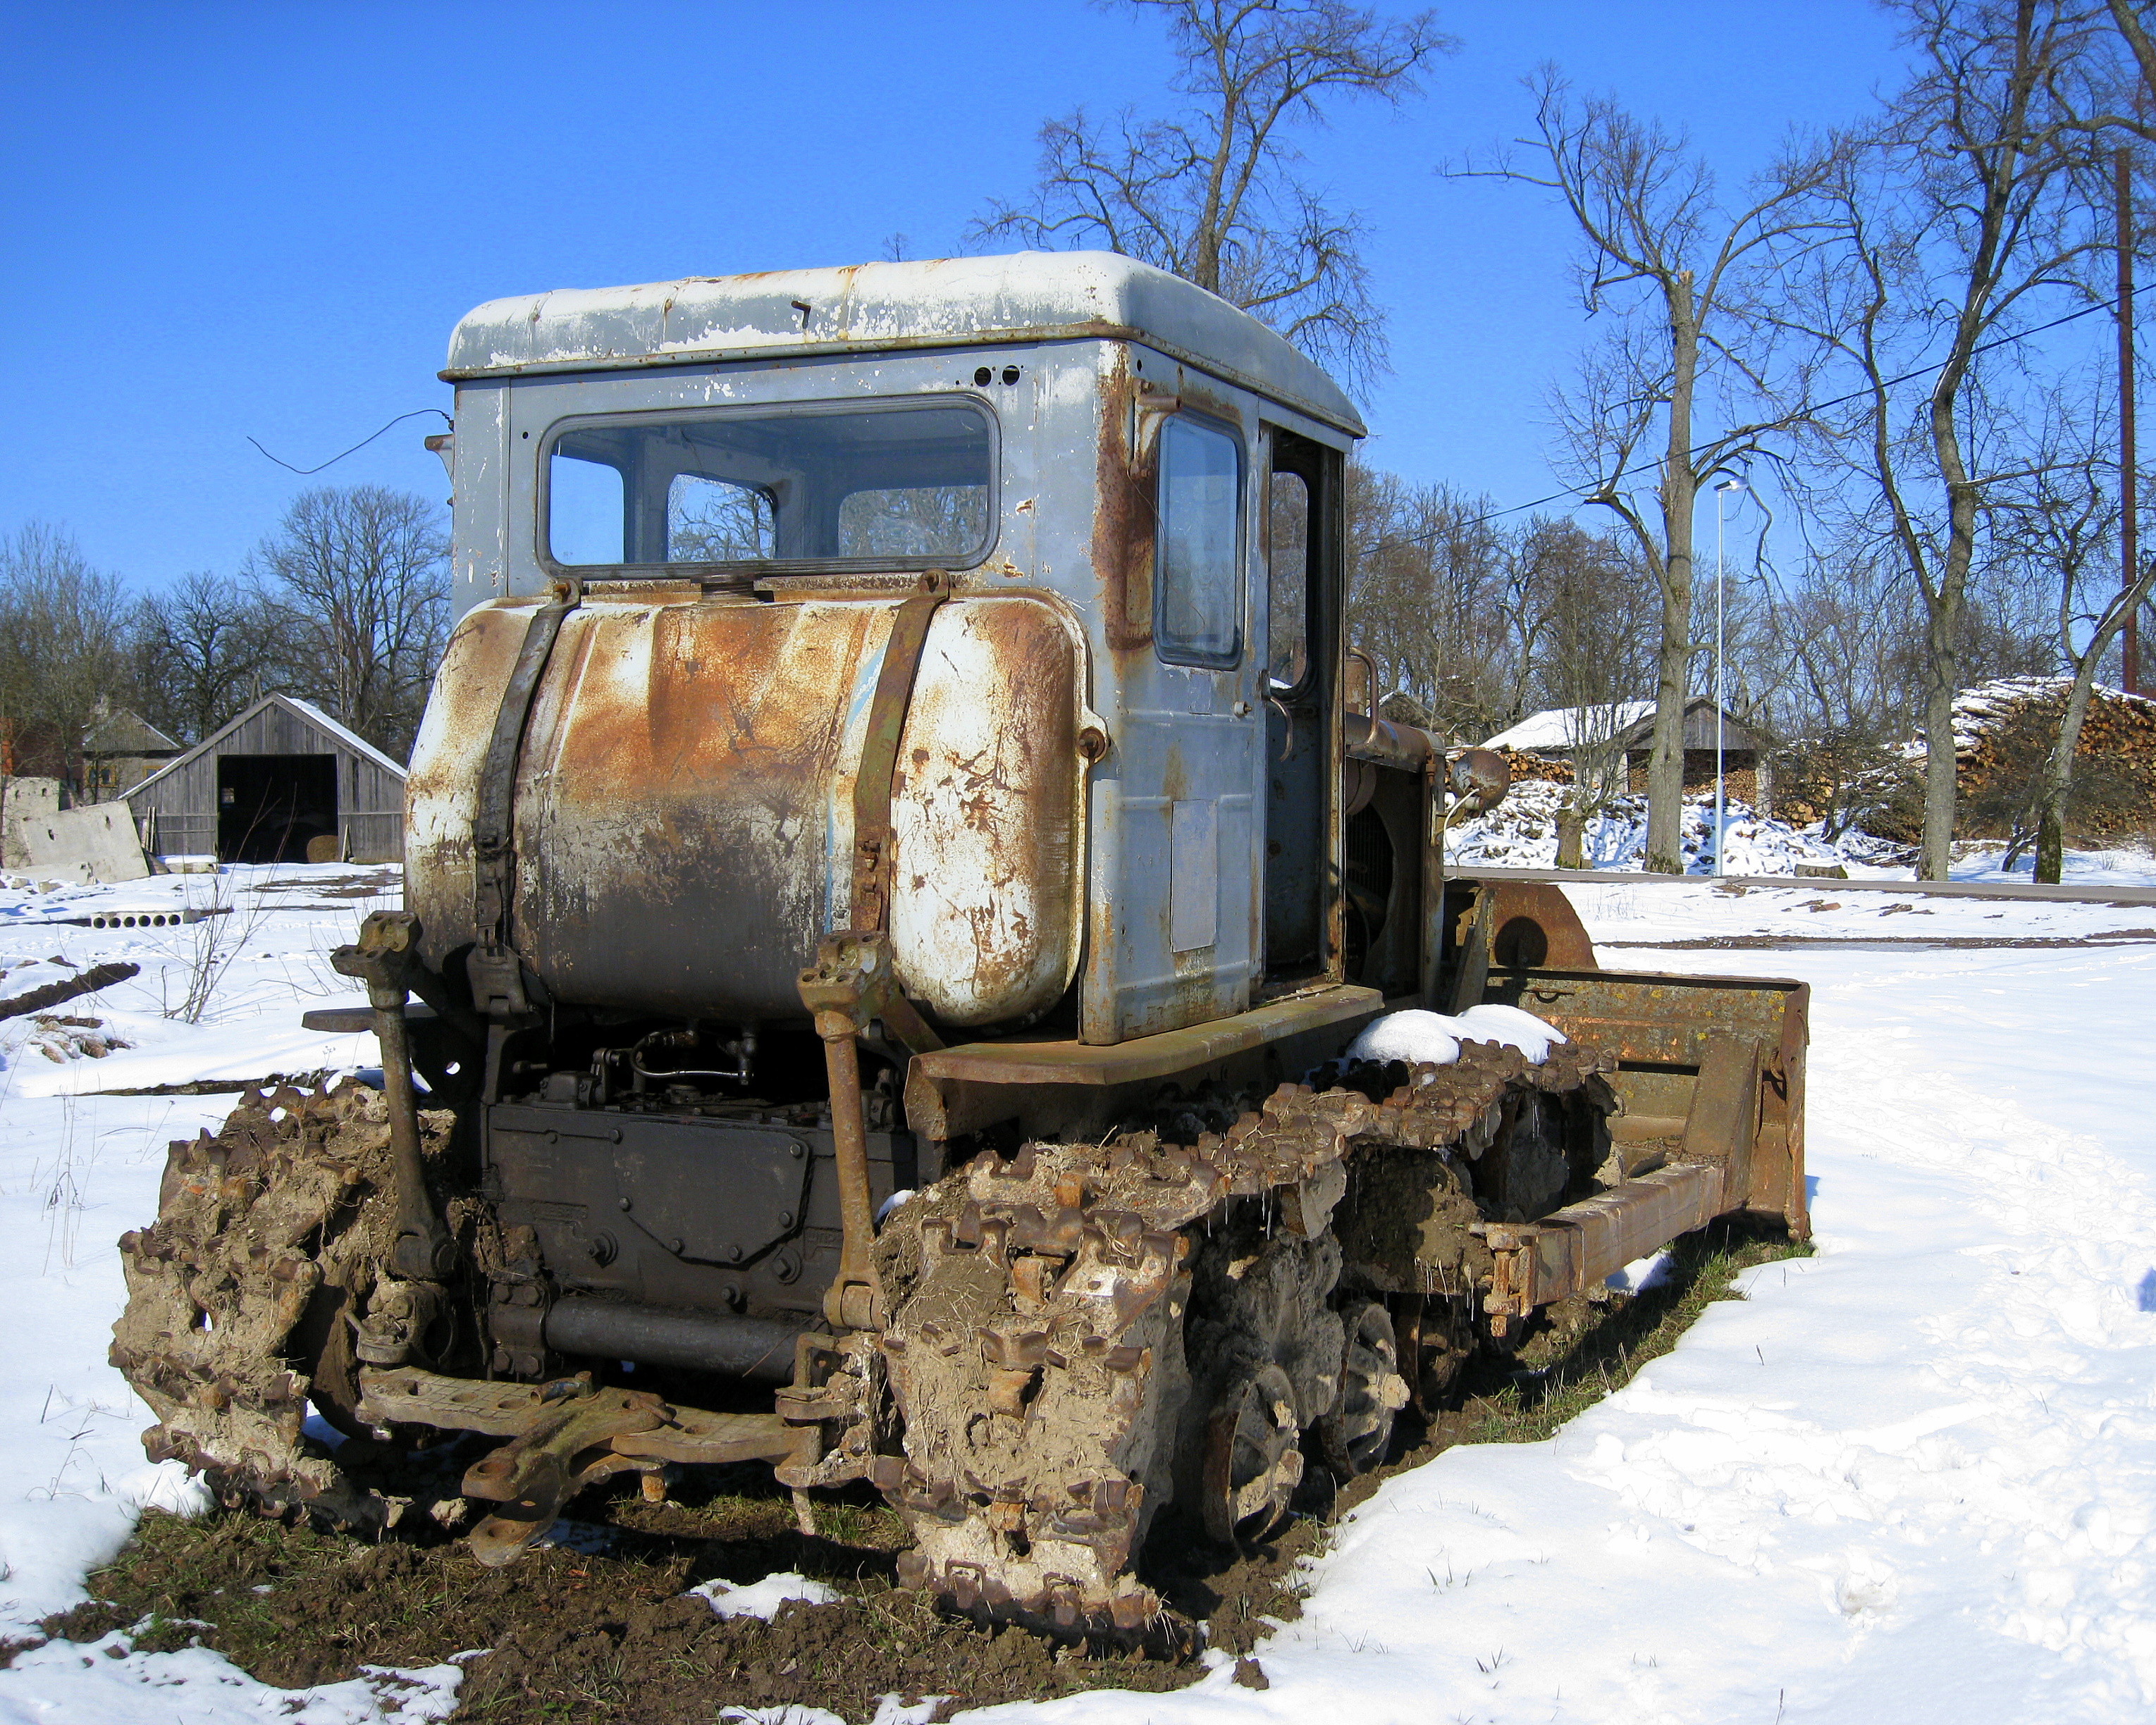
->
[112, 1080, 452, 1526]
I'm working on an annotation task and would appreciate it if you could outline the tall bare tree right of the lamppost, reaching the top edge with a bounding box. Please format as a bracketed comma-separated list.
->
[1783, 0, 2100, 879]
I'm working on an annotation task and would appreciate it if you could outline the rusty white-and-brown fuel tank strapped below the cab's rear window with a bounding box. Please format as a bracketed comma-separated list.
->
[405, 580, 1097, 1027]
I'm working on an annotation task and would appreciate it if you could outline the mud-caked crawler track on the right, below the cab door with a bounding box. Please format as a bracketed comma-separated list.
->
[865, 1044, 1613, 1634]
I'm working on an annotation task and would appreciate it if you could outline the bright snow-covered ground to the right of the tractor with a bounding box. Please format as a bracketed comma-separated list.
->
[996, 951, 2156, 1725]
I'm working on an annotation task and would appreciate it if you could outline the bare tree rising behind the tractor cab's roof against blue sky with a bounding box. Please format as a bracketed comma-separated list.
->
[971, 0, 1453, 380]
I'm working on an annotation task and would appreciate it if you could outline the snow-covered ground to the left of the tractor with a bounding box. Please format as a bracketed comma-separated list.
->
[0, 865, 460, 1725]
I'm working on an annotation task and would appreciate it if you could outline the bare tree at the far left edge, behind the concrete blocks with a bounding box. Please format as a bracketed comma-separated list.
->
[0, 522, 127, 789]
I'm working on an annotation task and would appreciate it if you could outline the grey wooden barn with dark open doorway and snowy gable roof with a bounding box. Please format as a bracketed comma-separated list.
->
[125, 694, 405, 863]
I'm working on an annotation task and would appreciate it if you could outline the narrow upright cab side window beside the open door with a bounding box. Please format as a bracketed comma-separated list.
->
[1154, 414, 1242, 669]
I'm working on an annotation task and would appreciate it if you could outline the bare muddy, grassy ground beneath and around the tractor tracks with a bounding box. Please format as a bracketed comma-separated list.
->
[20, 1223, 1802, 1725]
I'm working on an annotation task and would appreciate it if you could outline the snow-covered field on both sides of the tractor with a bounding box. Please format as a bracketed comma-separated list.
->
[0, 867, 2156, 1725]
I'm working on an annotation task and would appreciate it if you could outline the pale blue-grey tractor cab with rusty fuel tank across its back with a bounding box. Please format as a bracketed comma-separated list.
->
[412, 252, 1379, 1046]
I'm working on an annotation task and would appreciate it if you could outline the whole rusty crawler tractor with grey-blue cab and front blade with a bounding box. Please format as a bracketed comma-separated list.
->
[114, 254, 1804, 1632]
